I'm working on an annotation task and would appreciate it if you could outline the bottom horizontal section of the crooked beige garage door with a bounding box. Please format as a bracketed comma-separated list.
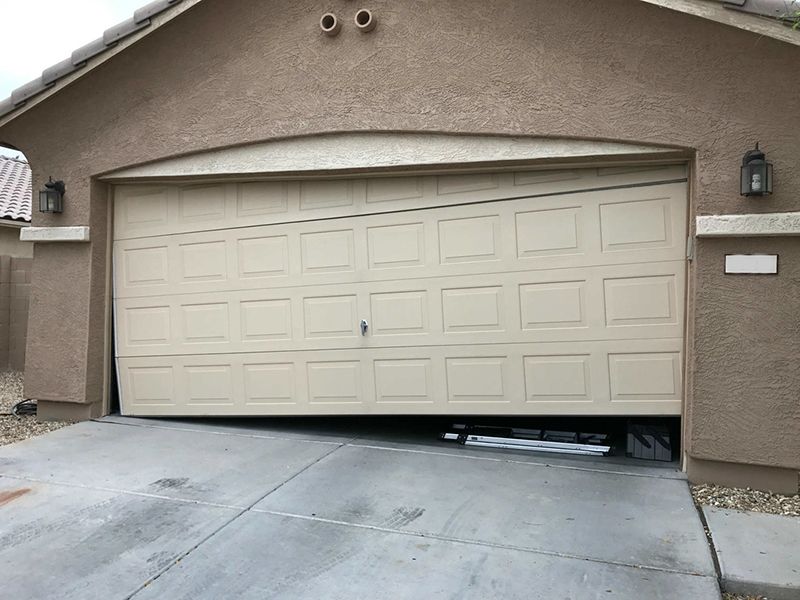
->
[120, 340, 682, 415]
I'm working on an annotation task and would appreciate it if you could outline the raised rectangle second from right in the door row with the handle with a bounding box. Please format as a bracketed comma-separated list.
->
[519, 281, 586, 330]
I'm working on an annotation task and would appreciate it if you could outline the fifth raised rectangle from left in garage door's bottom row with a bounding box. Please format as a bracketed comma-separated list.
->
[375, 359, 433, 404]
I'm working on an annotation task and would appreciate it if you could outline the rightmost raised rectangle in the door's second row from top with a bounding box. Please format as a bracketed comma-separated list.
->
[600, 198, 671, 251]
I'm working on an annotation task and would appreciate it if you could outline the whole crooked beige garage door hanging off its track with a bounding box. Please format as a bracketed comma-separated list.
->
[114, 166, 687, 416]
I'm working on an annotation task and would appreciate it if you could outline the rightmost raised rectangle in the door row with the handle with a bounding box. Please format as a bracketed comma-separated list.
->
[603, 275, 678, 327]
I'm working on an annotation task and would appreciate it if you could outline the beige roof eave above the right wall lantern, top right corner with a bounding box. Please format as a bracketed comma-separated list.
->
[641, 0, 800, 46]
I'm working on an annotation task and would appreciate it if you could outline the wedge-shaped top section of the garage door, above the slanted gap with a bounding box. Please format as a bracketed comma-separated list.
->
[114, 165, 686, 240]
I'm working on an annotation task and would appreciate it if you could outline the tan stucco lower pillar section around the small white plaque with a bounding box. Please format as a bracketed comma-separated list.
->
[691, 238, 800, 468]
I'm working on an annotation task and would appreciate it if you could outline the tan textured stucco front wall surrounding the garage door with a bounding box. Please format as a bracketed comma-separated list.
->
[0, 0, 800, 489]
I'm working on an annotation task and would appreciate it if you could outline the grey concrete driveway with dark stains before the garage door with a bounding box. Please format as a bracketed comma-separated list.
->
[0, 418, 719, 600]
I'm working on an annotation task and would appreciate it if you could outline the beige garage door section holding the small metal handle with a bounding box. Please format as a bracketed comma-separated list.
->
[117, 261, 685, 356]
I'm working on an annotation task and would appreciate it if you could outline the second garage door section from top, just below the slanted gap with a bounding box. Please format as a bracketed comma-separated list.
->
[115, 184, 686, 298]
